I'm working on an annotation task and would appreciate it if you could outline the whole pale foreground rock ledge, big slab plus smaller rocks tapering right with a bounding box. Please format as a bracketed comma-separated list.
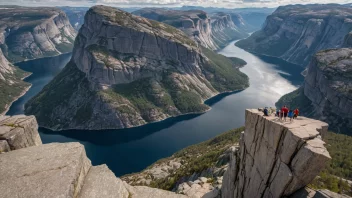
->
[0, 140, 186, 198]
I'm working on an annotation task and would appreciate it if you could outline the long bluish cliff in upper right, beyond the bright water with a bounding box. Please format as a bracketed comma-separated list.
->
[236, 4, 352, 66]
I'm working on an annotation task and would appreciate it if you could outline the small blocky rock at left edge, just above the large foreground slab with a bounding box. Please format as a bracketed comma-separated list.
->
[0, 115, 42, 153]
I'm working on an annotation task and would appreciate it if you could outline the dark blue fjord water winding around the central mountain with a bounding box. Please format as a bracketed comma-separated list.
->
[7, 42, 304, 176]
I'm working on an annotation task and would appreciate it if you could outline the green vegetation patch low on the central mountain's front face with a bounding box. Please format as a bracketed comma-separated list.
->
[106, 73, 208, 121]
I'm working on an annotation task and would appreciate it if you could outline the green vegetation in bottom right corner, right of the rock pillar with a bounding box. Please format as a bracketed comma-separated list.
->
[310, 132, 352, 196]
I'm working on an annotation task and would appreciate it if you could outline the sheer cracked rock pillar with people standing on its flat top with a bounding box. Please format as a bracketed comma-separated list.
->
[221, 110, 330, 198]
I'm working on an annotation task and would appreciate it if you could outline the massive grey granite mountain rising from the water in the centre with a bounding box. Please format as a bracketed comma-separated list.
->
[26, 6, 248, 130]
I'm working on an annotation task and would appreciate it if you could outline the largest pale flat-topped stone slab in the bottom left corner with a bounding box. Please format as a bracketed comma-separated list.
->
[0, 143, 91, 197]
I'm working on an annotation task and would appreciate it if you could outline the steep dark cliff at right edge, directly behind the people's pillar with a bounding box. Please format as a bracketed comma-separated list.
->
[277, 48, 352, 134]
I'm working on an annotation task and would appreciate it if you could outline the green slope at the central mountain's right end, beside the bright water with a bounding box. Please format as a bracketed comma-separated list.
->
[202, 47, 249, 92]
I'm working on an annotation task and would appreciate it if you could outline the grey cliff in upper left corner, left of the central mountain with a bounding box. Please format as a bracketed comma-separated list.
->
[0, 6, 76, 62]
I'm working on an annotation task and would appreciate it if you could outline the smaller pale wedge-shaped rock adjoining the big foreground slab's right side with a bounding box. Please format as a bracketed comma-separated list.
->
[78, 165, 129, 198]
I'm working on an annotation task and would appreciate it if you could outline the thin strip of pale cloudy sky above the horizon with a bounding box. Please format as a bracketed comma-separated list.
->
[0, 0, 352, 8]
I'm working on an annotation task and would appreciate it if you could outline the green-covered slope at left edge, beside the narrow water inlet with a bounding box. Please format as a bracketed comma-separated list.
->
[0, 67, 30, 113]
